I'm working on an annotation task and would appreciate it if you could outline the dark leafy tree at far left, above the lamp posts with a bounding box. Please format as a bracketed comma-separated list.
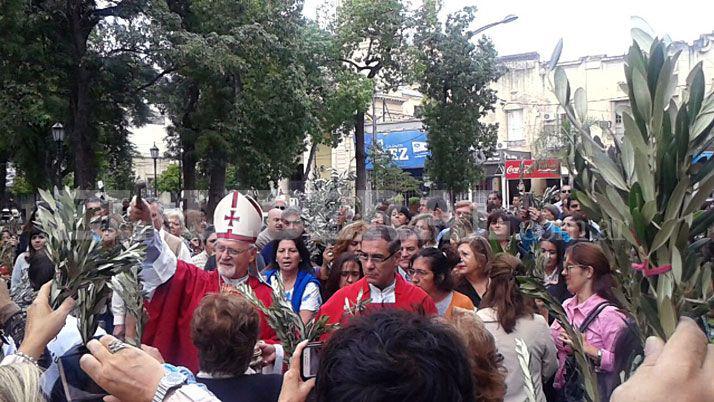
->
[0, 0, 170, 188]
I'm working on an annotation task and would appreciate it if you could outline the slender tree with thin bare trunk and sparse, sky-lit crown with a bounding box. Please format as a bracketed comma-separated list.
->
[329, 0, 410, 212]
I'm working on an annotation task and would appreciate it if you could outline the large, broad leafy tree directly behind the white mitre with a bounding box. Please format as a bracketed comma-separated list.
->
[162, 0, 364, 218]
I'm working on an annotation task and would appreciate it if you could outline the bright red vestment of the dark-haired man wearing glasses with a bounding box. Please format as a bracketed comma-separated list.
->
[318, 274, 437, 325]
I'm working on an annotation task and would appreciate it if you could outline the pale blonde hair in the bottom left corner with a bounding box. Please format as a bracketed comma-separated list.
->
[0, 363, 45, 402]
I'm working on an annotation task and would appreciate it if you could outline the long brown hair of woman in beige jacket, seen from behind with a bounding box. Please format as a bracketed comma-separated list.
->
[479, 253, 533, 334]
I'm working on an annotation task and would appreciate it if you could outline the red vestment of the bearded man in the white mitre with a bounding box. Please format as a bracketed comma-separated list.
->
[142, 260, 277, 373]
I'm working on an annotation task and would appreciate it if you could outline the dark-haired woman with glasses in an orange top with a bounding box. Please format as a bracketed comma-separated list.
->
[409, 247, 474, 318]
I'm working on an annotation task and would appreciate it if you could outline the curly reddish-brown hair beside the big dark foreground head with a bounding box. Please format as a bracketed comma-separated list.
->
[449, 307, 506, 402]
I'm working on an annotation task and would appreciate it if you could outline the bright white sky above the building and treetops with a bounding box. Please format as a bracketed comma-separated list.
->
[304, 0, 714, 61]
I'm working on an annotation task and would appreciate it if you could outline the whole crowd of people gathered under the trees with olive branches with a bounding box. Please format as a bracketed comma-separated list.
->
[0, 189, 714, 402]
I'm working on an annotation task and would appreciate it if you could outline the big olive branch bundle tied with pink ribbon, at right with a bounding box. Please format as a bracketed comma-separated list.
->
[555, 26, 714, 338]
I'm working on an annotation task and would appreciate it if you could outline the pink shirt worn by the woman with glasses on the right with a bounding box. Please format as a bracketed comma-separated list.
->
[550, 294, 627, 389]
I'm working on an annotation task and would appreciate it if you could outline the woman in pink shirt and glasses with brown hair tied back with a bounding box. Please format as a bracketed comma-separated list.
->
[551, 242, 627, 401]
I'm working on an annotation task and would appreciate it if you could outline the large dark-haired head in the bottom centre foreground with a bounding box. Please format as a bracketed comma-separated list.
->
[315, 310, 474, 402]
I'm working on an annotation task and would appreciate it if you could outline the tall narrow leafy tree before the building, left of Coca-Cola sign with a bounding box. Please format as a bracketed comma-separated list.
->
[415, 1, 501, 200]
